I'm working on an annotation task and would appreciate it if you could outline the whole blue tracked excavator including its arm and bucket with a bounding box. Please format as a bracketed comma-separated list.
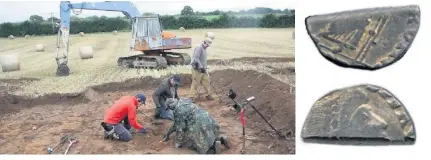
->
[56, 1, 192, 76]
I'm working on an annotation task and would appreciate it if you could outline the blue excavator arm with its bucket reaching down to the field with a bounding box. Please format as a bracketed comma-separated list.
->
[56, 1, 141, 76]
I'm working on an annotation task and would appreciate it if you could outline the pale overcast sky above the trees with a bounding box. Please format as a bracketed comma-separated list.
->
[0, 0, 295, 23]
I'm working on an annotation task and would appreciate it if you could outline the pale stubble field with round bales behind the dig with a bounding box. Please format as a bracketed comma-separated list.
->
[0, 29, 295, 96]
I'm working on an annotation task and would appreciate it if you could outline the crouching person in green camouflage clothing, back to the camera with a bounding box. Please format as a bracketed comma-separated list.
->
[162, 98, 230, 154]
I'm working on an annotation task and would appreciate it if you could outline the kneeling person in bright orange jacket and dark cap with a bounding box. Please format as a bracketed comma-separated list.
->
[101, 94, 147, 142]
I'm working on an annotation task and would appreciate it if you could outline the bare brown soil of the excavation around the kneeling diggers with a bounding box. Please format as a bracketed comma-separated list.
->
[0, 70, 295, 154]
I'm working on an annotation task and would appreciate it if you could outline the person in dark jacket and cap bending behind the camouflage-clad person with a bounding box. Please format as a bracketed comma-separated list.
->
[153, 74, 180, 120]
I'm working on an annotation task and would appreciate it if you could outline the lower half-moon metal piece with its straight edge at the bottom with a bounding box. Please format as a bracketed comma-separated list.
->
[301, 84, 416, 144]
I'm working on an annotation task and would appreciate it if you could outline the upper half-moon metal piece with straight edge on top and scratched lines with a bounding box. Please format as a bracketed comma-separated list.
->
[305, 5, 420, 70]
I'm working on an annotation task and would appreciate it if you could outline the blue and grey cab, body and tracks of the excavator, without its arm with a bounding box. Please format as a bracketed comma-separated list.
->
[117, 16, 191, 69]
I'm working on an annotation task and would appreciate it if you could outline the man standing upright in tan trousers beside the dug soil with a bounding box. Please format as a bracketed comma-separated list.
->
[189, 38, 214, 100]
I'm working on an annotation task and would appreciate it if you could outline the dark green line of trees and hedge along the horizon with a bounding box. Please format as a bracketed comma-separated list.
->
[0, 6, 295, 37]
